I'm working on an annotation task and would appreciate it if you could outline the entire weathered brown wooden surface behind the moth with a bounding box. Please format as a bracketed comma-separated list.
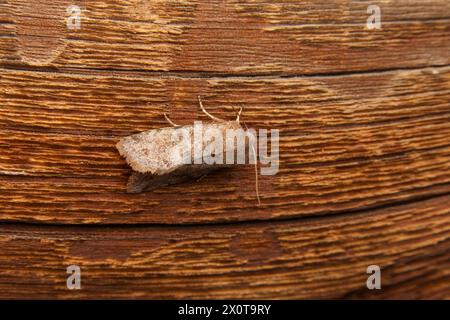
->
[0, 0, 450, 299]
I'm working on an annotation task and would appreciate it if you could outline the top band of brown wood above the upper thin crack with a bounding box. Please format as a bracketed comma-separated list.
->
[0, 0, 450, 74]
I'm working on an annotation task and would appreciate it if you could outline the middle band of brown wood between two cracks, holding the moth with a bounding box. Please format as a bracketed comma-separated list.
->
[0, 67, 450, 224]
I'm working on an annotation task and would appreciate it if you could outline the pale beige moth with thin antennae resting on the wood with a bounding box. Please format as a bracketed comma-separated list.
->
[116, 97, 260, 203]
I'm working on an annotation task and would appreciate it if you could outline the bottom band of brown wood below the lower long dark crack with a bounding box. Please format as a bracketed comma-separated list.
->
[0, 195, 450, 299]
